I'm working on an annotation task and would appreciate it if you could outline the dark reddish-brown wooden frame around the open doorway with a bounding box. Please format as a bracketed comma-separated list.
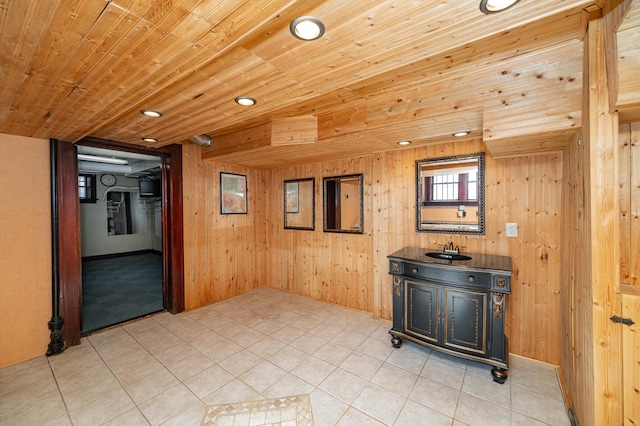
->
[57, 137, 184, 346]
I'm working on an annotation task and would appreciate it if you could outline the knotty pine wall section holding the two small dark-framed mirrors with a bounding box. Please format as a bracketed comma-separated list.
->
[265, 156, 375, 312]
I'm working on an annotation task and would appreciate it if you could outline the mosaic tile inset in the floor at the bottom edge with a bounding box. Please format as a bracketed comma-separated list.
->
[202, 395, 313, 426]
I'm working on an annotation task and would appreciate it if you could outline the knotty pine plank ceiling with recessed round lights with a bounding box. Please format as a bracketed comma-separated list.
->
[0, 0, 640, 168]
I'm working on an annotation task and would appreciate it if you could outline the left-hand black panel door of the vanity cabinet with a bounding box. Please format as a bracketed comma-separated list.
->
[404, 280, 440, 343]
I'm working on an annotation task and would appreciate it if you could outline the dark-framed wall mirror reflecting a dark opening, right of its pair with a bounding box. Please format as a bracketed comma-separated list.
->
[323, 174, 364, 234]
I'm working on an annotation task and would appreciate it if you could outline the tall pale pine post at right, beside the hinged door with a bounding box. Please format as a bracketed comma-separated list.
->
[581, 11, 623, 424]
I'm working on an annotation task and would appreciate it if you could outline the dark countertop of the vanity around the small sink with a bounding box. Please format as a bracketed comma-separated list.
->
[387, 247, 513, 275]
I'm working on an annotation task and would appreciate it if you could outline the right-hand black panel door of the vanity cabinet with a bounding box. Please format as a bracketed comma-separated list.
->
[443, 287, 487, 355]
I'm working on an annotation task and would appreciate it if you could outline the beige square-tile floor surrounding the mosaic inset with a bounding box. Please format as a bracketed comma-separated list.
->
[0, 288, 570, 426]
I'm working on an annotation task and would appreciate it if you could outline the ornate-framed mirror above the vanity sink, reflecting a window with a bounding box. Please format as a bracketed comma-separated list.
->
[416, 152, 484, 234]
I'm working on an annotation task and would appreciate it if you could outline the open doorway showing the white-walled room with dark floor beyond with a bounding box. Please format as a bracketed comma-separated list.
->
[77, 145, 164, 334]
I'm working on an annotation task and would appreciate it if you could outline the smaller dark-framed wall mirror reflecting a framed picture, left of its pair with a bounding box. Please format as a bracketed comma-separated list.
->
[284, 178, 315, 231]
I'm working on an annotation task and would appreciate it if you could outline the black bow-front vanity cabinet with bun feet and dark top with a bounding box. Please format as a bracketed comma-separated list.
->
[388, 247, 512, 383]
